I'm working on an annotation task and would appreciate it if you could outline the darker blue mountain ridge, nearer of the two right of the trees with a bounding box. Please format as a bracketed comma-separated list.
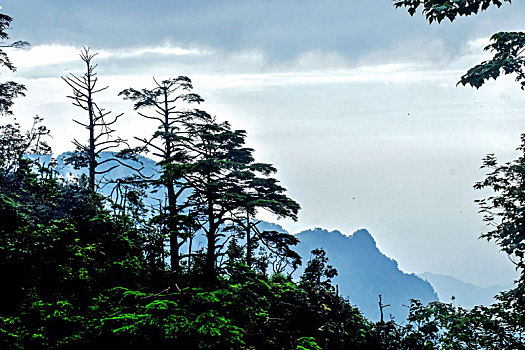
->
[296, 228, 438, 322]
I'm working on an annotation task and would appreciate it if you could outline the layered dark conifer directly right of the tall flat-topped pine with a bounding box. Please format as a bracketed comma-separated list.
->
[184, 116, 245, 283]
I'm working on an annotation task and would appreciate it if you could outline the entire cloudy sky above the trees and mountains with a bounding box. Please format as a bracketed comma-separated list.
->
[0, 0, 525, 286]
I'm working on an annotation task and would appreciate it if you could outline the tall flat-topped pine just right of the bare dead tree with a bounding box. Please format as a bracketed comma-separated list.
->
[120, 76, 203, 279]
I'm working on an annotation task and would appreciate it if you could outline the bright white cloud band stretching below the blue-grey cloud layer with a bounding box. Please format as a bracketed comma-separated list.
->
[2, 38, 486, 88]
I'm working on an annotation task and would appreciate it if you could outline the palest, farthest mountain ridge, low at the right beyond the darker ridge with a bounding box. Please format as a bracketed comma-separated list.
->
[418, 272, 513, 308]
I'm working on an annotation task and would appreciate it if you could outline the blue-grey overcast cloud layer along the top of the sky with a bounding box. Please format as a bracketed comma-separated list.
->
[3, 0, 525, 61]
